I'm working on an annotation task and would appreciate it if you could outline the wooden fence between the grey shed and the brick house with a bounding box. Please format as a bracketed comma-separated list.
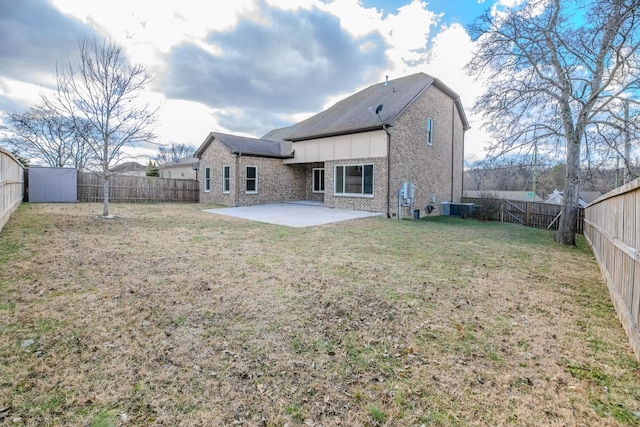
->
[78, 172, 200, 203]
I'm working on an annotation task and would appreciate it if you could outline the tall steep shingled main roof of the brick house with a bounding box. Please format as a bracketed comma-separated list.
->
[263, 73, 469, 141]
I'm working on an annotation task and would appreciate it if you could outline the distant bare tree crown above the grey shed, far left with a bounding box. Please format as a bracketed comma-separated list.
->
[7, 107, 89, 170]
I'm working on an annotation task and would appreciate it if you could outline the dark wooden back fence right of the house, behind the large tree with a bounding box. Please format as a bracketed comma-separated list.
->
[463, 197, 584, 234]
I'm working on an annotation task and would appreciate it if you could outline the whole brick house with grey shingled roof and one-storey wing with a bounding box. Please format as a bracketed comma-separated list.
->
[195, 73, 469, 217]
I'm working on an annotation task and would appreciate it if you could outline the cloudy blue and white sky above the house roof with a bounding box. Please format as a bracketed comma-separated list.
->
[0, 0, 521, 161]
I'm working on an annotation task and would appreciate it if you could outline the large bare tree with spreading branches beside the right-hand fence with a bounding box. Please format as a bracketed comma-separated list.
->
[468, 0, 640, 245]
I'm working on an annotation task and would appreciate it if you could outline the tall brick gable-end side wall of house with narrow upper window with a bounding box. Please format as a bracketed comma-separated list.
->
[390, 86, 464, 217]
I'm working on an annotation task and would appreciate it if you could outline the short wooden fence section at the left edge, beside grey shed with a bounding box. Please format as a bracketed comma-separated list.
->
[0, 148, 24, 230]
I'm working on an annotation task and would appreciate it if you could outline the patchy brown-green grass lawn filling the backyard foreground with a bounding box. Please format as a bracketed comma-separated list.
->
[0, 204, 640, 427]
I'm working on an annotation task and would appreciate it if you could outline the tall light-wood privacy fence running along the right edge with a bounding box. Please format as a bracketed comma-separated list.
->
[584, 179, 640, 361]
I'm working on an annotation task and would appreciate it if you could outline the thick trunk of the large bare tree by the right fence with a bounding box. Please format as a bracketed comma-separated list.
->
[556, 136, 580, 246]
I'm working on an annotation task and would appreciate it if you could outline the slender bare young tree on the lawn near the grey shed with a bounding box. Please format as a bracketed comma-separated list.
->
[43, 39, 157, 216]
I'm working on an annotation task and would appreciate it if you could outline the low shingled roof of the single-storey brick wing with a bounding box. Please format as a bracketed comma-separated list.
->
[194, 132, 293, 159]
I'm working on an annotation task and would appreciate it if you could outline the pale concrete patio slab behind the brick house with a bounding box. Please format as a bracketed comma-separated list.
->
[205, 202, 383, 227]
